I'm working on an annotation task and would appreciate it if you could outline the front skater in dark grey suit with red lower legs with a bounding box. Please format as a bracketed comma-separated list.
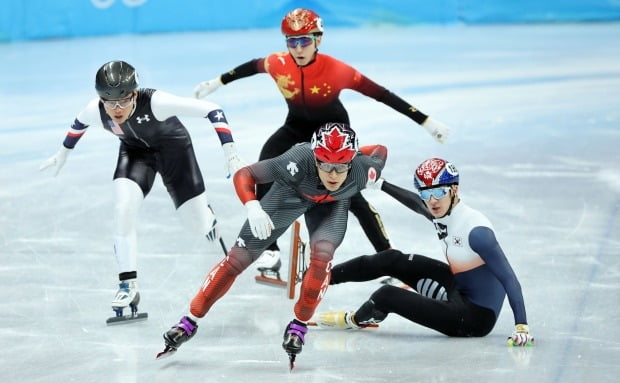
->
[164, 123, 387, 366]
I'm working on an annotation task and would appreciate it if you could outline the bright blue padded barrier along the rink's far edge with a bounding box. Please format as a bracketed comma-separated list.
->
[0, 0, 620, 41]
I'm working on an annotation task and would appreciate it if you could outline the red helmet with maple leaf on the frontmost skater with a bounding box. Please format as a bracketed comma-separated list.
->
[310, 122, 358, 164]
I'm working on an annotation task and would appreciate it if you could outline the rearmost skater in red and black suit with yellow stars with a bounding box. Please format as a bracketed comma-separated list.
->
[195, 8, 449, 270]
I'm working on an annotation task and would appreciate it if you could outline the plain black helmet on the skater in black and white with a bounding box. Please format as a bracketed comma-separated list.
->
[95, 61, 138, 100]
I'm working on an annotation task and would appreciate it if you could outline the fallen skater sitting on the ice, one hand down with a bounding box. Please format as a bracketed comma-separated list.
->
[316, 158, 533, 346]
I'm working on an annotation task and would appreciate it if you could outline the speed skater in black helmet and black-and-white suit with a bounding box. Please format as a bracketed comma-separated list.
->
[41, 61, 244, 318]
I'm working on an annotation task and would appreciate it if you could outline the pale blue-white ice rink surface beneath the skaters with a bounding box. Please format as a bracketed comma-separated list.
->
[0, 23, 620, 383]
